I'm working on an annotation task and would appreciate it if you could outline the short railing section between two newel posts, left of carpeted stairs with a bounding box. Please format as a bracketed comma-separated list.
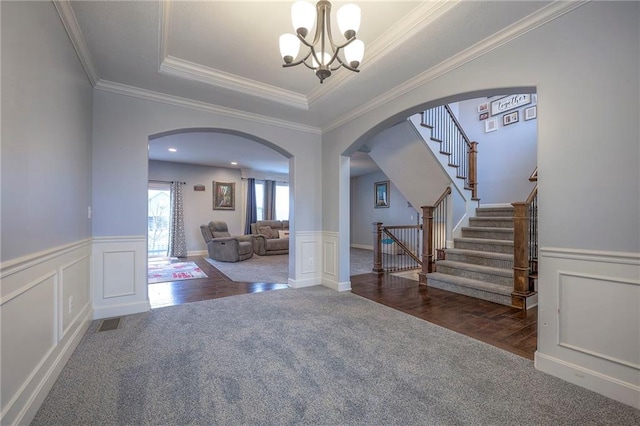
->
[373, 222, 422, 275]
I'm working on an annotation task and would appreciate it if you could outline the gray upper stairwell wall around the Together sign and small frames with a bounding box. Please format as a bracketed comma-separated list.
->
[457, 96, 538, 204]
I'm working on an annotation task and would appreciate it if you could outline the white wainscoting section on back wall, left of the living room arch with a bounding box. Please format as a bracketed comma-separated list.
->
[92, 236, 150, 319]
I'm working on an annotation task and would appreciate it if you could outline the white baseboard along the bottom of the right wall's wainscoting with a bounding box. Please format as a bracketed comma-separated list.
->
[534, 352, 640, 409]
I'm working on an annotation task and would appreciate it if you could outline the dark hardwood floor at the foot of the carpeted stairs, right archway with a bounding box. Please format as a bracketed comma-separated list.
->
[351, 274, 538, 360]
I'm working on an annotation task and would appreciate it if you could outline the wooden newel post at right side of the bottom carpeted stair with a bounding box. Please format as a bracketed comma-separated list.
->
[511, 202, 529, 309]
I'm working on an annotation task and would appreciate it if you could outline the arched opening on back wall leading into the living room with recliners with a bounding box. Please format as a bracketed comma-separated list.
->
[147, 128, 294, 308]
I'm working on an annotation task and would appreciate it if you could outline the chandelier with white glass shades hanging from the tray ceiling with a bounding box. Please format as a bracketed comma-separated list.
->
[280, 0, 364, 83]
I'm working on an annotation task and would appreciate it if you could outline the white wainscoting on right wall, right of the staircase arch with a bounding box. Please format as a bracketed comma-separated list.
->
[535, 248, 640, 408]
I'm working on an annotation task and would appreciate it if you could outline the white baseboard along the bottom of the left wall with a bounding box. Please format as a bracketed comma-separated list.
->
[9, 305, 93, 425]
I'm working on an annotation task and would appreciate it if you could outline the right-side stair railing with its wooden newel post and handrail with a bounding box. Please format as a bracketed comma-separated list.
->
[511, 168, 538, 312]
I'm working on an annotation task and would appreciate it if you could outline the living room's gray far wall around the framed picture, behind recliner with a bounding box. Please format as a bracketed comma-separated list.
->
[149, 161, 245, 251]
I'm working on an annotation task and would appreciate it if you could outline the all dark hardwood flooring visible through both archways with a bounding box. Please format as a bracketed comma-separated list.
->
[149, 257, 538, 359]
